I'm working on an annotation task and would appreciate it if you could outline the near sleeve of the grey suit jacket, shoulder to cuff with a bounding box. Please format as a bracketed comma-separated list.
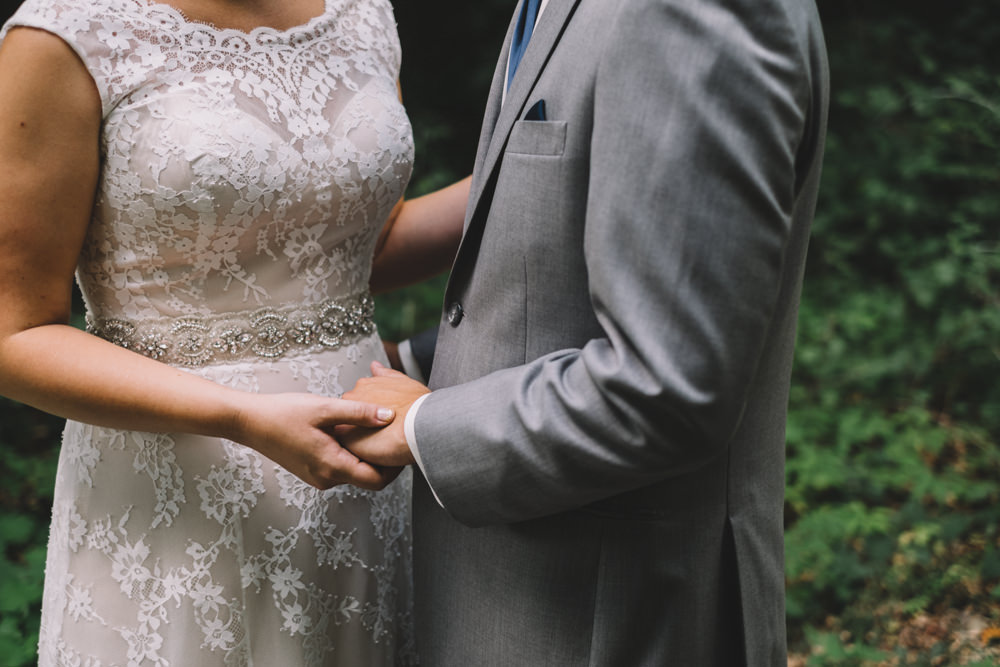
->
[415, 0, 811, 525]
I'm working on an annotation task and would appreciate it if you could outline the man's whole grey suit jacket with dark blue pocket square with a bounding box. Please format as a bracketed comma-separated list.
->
[413, 0, 828, 667]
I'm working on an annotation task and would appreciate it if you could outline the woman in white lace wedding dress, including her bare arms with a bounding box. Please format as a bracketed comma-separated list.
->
[0, 0, 467, 667]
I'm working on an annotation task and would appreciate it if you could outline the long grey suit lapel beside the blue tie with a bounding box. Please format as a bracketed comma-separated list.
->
[466, 0, 580, 228]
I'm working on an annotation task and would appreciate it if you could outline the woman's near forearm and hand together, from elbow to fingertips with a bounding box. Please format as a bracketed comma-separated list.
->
[0, 324, 398, 489]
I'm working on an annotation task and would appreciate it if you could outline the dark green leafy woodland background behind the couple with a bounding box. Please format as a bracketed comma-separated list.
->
[0, 0, 1000, 666]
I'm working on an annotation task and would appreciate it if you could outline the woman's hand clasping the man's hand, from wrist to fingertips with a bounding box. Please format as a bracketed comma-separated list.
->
[232, 394, 399, 490]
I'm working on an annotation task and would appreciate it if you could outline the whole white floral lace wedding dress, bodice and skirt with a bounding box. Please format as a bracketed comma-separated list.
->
[0, 0, 414, 667]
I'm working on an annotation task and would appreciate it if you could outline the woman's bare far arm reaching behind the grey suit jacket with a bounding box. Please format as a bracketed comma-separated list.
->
[370, 177, 472, 293]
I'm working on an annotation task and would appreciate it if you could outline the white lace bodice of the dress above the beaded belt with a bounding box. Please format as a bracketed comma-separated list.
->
[1, 0, 413, 321]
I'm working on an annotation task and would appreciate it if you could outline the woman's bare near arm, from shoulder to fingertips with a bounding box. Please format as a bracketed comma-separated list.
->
[0, 28, 391, 488]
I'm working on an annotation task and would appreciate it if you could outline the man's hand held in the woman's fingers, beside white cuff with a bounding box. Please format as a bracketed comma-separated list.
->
[337, 362, 430, 467]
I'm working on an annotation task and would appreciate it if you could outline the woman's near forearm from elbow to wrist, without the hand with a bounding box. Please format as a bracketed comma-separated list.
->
[0, 324, 250, 439]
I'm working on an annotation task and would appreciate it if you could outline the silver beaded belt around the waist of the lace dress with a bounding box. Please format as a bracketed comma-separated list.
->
[87, 292, 375, 366]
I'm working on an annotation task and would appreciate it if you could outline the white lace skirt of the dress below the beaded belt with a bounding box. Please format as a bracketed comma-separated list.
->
[39, 334, 415, 667]
